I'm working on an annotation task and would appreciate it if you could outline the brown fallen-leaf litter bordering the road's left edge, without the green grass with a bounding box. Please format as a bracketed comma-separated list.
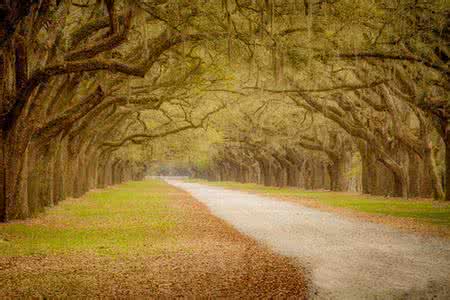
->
[0, 188, 307, 299]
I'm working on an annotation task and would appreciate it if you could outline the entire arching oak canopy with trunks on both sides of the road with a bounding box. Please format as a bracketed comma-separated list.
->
[0, 0, 450, 221]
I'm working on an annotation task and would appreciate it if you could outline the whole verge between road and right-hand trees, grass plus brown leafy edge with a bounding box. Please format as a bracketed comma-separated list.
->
[185, 179, 450, 238]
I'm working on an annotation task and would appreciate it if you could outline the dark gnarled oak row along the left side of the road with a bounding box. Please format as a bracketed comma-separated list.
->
[0, 0, 230, 222]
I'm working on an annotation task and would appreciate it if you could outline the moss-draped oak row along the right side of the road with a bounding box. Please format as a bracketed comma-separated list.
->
[191, 0, 450, 200]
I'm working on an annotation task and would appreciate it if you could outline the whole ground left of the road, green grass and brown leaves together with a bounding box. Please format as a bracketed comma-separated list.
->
[0, 180, 307, 299]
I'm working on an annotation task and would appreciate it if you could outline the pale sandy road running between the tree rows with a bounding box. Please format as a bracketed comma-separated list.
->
[167, 180, 450, 299]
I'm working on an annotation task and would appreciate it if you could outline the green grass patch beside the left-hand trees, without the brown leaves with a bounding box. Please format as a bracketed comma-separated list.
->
[0, 181, 176, 256]
